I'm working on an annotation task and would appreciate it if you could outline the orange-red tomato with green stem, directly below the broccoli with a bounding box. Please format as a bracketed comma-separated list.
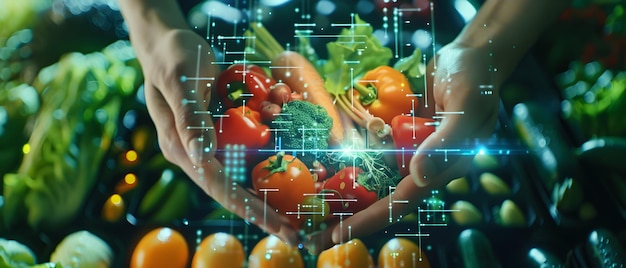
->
[252, 152, 315, 229]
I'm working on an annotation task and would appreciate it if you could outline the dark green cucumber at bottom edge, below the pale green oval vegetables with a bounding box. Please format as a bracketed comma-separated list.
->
[458, 229, 501, 268]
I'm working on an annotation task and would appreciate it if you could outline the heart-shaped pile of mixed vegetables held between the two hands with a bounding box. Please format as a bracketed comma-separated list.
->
[211, 16, 435, 232]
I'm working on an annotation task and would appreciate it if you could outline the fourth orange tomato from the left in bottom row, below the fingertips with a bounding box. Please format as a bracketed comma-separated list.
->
[317, 238, 374, 268]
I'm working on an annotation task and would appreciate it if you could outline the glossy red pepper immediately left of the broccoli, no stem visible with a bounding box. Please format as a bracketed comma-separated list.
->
[215, 106, 271, 153]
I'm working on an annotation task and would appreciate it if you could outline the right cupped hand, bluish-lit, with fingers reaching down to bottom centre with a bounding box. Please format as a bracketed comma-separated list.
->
[307, 42, 503, 253]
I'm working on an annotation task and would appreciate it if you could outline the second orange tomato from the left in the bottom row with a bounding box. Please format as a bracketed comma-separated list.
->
[191, 232, 246, 268]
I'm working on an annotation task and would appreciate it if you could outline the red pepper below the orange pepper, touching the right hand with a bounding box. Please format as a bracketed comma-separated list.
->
[391, 115, 435, 177]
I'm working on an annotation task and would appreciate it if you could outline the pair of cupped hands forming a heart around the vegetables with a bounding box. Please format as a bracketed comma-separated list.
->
[138, 30, 499, 253]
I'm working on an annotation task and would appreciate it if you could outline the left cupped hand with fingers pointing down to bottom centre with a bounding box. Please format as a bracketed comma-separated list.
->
[137, 29, 298, 244]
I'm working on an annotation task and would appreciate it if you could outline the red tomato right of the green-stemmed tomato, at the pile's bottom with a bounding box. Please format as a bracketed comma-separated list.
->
[322, 167, 378, 215]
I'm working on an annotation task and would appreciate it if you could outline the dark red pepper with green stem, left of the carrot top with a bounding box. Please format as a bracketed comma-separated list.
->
[217, 64, 276, 111]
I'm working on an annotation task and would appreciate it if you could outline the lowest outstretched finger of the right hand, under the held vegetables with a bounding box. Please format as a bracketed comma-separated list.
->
[332, 175, 435, 246]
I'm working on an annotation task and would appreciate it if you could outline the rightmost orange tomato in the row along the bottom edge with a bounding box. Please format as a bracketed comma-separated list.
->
[378, 238, 430, 268]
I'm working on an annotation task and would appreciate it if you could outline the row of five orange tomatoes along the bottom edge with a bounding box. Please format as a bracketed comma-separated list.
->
[129, 227, 430, 268]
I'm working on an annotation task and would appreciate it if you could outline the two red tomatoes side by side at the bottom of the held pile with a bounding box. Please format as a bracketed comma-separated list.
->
[252, 152, 378, 232]
